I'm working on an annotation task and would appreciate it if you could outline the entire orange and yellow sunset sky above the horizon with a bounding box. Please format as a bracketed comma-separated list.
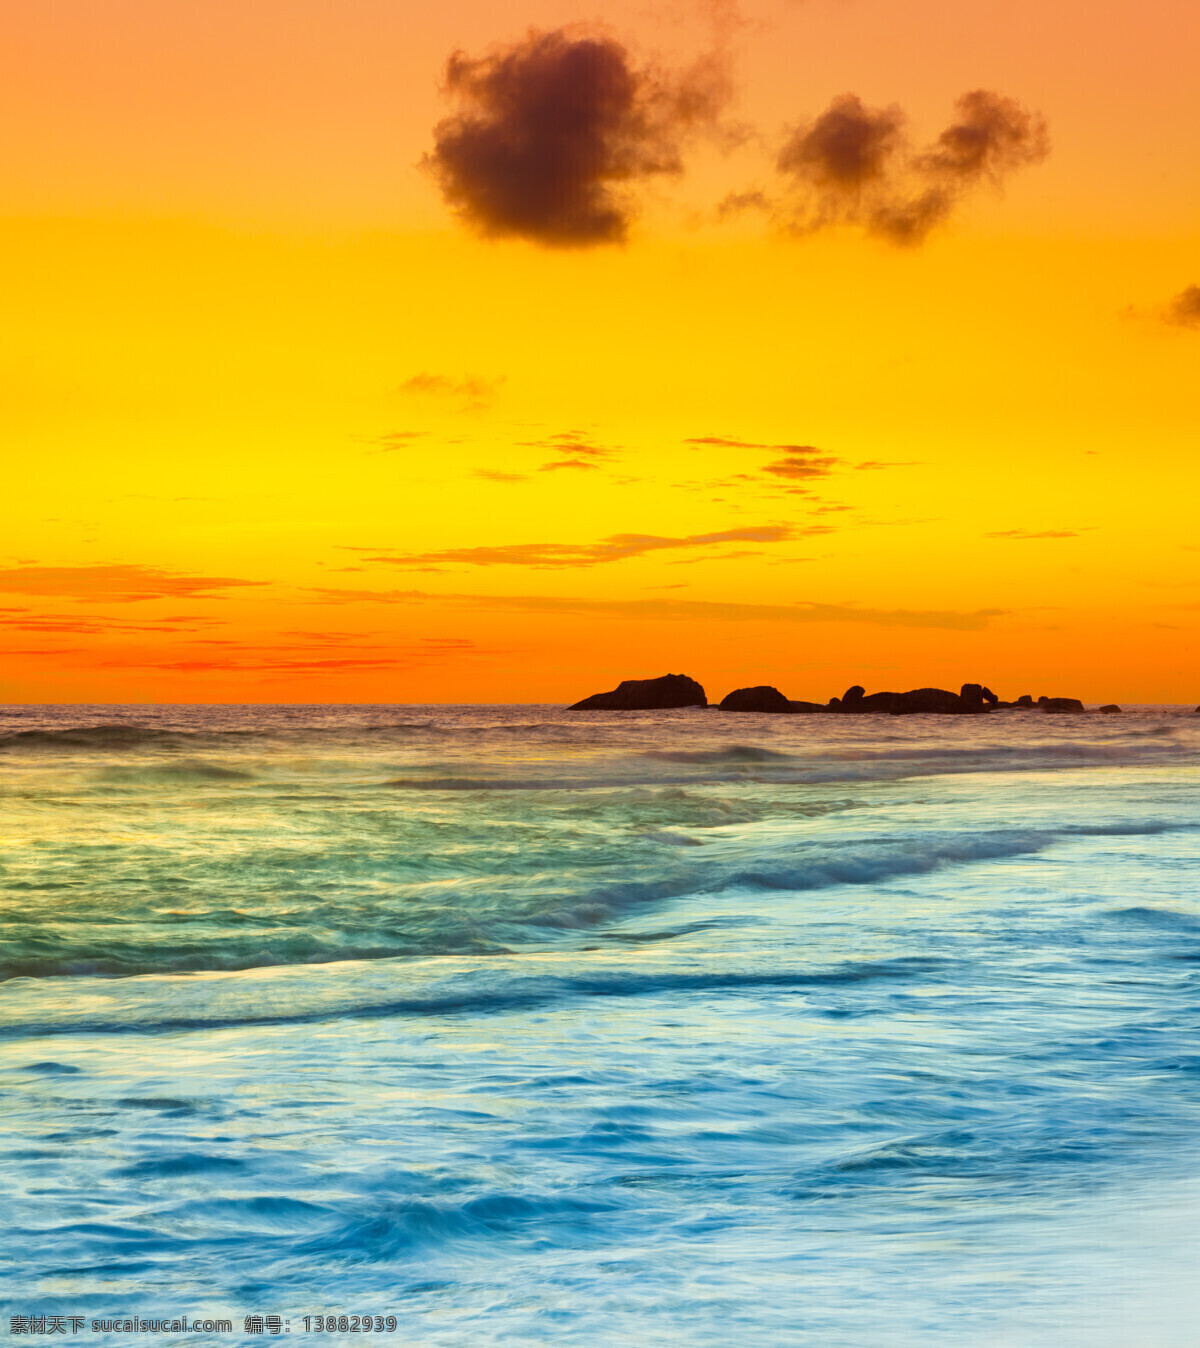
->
[0, 0, 1200, 702]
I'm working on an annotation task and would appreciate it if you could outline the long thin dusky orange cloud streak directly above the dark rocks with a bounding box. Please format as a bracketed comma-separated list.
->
[313, 589, 1007, 632]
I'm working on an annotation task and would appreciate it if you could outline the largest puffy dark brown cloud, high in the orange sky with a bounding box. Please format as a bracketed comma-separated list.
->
[423, 28, 731, 248]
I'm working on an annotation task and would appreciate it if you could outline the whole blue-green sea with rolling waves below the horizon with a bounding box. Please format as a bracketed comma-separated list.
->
[0, 706, 1200, 1348]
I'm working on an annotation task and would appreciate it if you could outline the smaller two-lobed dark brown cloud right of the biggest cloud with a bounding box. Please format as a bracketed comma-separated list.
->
[775, 89, 1050, 244]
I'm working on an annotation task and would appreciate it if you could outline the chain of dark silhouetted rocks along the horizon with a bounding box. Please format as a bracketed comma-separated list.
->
[568, 674, 1111, 716]
